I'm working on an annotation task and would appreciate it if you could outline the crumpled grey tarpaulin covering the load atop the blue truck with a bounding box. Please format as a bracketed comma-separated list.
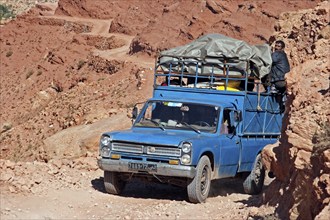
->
[159, 34, 272, 78]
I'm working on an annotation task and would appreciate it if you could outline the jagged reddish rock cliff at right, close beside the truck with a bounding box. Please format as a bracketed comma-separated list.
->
[263, 2, 330, 219]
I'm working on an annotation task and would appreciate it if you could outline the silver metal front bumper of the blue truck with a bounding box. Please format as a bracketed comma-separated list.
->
[97, 158, 196, 178]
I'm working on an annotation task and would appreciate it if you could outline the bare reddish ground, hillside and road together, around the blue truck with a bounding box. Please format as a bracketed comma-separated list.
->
[0, 0, 328, 219]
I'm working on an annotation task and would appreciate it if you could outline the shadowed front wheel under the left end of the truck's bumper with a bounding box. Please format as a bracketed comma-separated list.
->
[104, 171, 126, 195]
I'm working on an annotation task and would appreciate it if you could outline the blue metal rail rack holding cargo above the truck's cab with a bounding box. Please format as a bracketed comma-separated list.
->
[154, 55, 257, 91]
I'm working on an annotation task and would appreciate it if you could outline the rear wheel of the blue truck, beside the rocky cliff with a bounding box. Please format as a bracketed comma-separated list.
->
[243, 154, 265, 195]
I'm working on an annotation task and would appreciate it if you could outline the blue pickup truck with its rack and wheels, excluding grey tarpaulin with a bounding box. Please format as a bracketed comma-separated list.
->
[98, 34, 283, 203]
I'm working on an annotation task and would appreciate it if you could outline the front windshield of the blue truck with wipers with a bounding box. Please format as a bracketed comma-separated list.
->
[134, 101, 220, 133]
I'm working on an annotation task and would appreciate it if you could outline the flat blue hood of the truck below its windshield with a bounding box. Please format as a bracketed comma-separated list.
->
[107, 128, 210, 146]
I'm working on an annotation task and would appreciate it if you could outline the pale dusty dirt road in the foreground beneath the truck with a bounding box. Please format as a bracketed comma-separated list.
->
[0, 164, 276, 219]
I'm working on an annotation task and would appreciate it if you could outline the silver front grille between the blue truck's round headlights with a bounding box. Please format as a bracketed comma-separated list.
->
[112, 143, 181, 157]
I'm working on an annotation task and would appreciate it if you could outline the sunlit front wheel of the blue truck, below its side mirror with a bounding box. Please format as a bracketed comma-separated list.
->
[187, 155, 212, 203]
